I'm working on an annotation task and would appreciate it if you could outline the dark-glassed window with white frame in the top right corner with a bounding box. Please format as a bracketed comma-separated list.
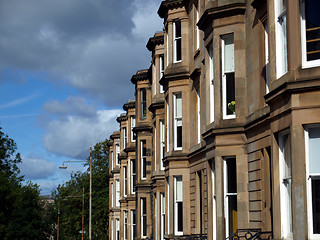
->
[301, 0, 320, 67]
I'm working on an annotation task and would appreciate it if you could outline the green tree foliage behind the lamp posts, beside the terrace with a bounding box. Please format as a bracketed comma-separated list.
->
[54, 139, 109, 239]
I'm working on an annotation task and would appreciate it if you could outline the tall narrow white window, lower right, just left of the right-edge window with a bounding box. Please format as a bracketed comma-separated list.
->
[279, 131, 292, 238]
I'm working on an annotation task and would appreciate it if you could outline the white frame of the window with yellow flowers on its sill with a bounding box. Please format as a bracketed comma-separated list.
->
[221, 33, 236, 119]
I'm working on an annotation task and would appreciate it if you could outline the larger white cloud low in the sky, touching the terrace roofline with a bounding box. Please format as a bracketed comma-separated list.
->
[43, 110, 121, 159]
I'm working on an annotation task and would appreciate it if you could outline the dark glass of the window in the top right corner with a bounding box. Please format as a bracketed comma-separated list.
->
[305, 0, 320, 61]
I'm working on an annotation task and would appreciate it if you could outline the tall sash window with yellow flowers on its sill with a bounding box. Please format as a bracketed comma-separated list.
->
[222, 34, 235, 119]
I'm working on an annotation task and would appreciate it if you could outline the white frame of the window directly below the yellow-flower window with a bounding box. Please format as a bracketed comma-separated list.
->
[223, 156, 238, 236]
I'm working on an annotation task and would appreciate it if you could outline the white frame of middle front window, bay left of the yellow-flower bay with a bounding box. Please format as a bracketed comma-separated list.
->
[173, 92, 183, 151]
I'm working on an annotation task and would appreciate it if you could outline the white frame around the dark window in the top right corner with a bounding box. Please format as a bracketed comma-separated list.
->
[300, 0, 320, 68]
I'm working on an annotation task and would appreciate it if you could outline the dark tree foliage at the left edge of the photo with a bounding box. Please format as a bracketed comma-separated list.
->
[0, 127, 53, 240]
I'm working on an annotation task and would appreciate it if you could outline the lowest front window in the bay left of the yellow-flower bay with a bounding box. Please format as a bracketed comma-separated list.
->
[174, 176, 183, 235]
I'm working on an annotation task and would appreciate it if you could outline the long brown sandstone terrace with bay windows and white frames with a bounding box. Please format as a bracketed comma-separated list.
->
[109, 0, 320, 240]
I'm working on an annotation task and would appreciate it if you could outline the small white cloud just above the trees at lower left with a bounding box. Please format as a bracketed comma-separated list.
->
[19, 157, 57, 180]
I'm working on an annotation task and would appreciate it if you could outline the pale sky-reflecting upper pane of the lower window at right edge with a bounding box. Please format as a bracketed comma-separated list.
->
[309, 128, 320, 173]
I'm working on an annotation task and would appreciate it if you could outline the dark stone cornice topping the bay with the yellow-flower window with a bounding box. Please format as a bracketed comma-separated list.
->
[197, 3, 246, 31]
